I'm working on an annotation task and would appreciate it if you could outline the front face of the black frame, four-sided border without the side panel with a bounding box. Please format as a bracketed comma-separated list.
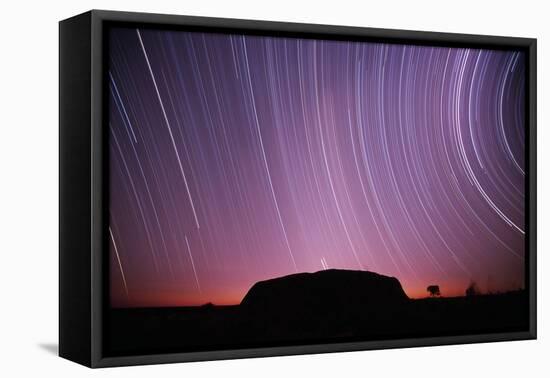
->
[85, 10, 537, 367]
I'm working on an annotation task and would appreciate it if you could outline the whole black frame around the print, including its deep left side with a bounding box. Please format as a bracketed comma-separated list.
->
[59, 10, 537, 367]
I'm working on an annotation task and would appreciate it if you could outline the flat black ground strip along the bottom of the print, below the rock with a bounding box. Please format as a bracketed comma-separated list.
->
[106, 291, 528, 355]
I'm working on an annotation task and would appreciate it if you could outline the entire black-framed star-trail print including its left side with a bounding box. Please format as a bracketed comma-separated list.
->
[59, 11, 536, 367]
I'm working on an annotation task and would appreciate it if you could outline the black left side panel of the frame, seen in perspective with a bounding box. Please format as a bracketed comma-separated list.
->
[59, 12, 92, 366]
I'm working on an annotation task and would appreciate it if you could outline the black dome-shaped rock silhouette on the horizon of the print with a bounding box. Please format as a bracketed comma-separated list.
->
[241, 269, 409, 316]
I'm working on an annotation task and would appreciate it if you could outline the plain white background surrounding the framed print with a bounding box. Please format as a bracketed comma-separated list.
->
[0, 0, 550, 378]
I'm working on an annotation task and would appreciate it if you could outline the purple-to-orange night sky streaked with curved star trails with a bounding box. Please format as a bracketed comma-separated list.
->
[107, 28, 526, 307]
